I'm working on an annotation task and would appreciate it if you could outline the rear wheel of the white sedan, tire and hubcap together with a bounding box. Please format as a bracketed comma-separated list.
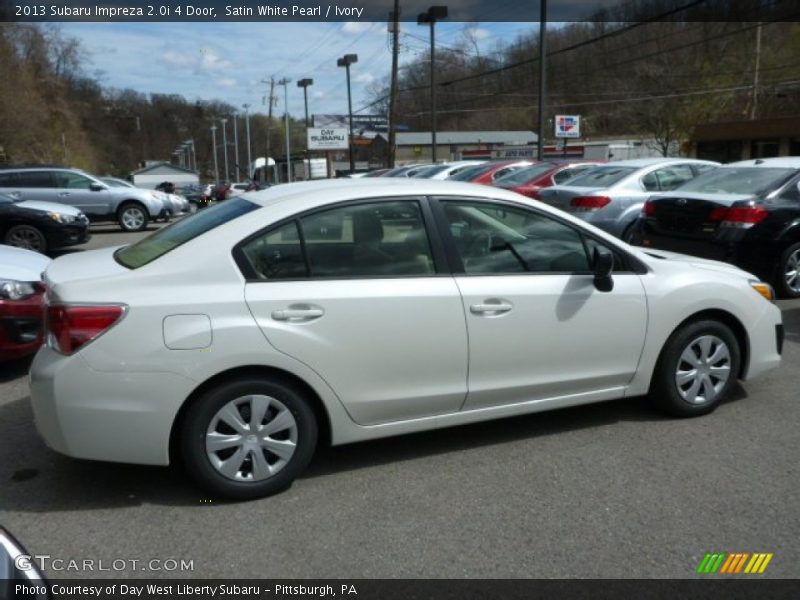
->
[180, 378, 317, 500]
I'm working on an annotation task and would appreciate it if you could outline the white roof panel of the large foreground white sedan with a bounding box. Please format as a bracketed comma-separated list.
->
[240, 177, 523, 206]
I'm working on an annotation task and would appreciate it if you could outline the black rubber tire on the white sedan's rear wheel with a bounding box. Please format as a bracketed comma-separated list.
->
[179, 377, 318, 500]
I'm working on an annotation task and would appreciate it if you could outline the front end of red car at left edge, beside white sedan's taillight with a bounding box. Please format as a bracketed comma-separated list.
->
[0, 246, 50, 361]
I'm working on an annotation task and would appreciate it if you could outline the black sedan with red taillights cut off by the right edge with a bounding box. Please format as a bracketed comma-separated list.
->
[633, 157, 800, 298]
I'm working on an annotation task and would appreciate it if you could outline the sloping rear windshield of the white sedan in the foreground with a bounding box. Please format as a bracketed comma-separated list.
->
[114, 197, 259, 269]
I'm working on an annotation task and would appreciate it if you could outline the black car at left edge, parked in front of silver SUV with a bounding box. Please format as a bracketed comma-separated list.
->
[0, 194, 91, 253]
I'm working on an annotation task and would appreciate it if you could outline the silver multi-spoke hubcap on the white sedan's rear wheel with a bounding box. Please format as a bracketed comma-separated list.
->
[206, 395, 297, 482]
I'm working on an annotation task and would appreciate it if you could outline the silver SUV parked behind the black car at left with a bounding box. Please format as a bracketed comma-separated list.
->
[0, 167, 167, 231]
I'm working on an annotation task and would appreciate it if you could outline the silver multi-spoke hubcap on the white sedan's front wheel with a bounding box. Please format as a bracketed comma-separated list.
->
[675, 335, 731, 404]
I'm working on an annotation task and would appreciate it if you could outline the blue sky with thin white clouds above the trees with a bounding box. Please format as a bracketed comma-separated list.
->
[62, 21, 538, 117]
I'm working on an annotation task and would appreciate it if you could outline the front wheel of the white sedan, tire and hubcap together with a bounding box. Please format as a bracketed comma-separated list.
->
[650, 320, 741, 417]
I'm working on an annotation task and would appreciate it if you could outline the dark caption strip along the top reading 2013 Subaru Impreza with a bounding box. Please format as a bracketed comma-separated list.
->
[0, 0, 800, 22]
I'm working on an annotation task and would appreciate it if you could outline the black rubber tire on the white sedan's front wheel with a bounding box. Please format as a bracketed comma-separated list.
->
[650, 320, 741, 417]
